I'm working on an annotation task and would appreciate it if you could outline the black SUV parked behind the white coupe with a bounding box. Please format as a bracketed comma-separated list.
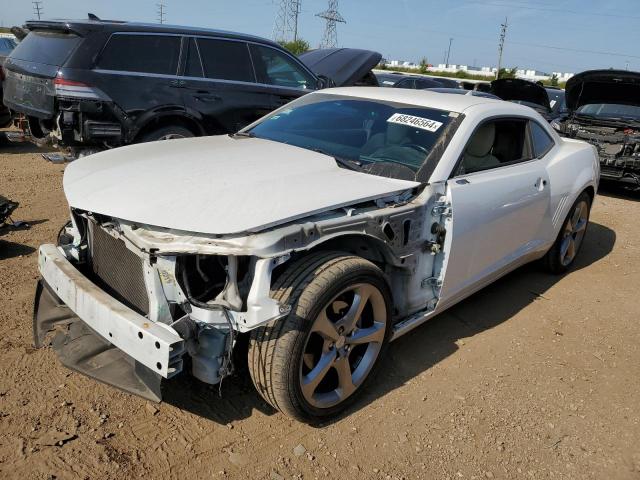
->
[4, 16, 380, 148]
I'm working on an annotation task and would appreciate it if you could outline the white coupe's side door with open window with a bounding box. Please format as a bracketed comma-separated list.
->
[440, 118, 552, 305]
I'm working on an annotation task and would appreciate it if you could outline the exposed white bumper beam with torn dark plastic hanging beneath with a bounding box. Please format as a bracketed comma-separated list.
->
[33, 245, 185, 401]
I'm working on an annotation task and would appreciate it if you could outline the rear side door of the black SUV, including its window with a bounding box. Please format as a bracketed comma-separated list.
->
[178, 37, 273, 134]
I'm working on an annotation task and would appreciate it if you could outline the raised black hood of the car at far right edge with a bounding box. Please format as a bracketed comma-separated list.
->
[565, 70, 640, 111]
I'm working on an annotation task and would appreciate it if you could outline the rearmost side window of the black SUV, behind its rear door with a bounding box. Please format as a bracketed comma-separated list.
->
[98, 34, 180, 75]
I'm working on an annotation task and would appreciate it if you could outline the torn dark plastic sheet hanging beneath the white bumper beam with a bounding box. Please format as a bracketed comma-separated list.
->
[33, 280, 162, 402]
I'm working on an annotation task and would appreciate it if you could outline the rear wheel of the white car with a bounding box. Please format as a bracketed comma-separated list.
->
[543, 192, 591, 274]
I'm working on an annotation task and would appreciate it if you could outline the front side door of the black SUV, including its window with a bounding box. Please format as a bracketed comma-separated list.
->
[249, 43, 318, 110]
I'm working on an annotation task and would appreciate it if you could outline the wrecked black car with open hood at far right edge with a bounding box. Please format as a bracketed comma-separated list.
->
[554, 70, 640, 189]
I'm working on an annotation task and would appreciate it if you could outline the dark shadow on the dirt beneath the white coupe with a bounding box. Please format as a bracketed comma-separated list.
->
[163, 222, 616, 426]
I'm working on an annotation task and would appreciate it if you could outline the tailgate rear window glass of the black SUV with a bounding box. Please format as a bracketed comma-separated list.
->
[11, 31, 82, 66]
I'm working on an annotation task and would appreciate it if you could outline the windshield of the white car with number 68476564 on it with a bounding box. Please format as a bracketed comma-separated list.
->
[246, 93, 459, 180]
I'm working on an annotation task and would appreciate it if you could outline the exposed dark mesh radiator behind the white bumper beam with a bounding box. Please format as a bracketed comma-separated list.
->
[89, 222, 149, 315]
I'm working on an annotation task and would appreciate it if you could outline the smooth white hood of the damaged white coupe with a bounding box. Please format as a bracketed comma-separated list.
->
[64, 135, 419, 235]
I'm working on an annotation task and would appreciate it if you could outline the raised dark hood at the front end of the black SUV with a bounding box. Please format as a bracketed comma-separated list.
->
[298, 48, 382, 87]
